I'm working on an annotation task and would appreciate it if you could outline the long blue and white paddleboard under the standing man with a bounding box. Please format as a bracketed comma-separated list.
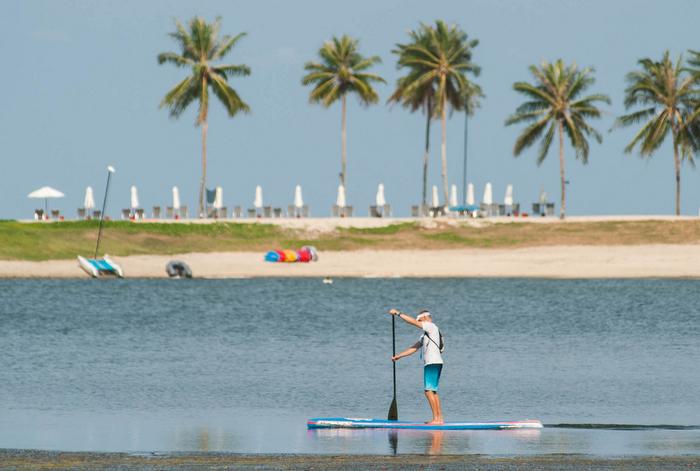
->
[306, 417, 542, 430]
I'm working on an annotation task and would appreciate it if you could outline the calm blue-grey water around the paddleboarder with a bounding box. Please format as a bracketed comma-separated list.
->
[0, 279, 700, 456]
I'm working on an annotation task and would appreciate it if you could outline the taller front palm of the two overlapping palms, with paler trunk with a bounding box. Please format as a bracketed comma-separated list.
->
[397, 20, 480, 203]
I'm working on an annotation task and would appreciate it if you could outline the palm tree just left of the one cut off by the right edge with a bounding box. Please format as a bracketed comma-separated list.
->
[615, 51, 699, 216]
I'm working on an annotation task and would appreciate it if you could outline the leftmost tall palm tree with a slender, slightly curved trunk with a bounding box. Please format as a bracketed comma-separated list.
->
[158, 17, 250, 217]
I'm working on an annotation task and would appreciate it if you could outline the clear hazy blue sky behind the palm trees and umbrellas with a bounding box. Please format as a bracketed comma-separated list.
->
[0, 0, 700, 219]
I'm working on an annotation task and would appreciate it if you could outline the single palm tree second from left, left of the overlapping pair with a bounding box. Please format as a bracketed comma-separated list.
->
[301, 35, 386, 191]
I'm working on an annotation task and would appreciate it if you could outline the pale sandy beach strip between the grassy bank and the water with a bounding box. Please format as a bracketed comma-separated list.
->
[0, 245, 700, 278]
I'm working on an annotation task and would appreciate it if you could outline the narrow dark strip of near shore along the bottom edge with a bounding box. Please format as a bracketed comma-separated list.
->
[0, 449, 700, 471]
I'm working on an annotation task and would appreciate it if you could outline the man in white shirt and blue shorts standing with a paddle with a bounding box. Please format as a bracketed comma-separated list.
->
[389, 309, 444, 424]
